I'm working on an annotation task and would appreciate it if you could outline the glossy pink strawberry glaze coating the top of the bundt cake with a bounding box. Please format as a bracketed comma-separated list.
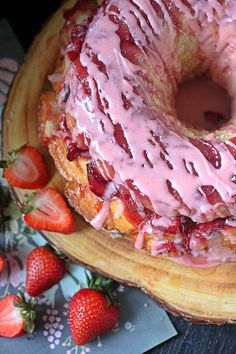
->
[58, 0, 236, 264]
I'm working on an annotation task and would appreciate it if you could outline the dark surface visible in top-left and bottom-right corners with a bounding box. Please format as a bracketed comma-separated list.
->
[0, 0, 236, 354]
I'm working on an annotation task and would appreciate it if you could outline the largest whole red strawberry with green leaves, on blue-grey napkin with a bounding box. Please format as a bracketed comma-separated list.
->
[69, 275, 120, 345]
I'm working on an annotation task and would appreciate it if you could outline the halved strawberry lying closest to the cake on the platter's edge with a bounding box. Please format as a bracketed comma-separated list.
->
[22, 188, 76, 234]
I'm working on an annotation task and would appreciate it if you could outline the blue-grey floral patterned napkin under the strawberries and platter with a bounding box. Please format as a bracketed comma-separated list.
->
[0, 20, 176, 354]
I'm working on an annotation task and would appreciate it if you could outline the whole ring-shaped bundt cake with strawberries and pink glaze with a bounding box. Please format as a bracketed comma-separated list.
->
[38, 0, 236, 266]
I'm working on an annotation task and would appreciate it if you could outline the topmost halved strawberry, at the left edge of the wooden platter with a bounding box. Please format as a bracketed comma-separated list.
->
[1, 146, 49, 189]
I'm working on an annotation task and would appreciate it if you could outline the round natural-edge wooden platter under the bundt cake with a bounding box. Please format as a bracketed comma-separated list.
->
[4, 0, 236, 324]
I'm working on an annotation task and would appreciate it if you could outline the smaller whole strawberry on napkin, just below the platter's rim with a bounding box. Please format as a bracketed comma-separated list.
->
[26, 246, 66, 296]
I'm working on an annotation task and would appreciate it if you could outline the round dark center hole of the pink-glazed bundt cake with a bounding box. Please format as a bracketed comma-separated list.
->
[175, 76, 231, 131]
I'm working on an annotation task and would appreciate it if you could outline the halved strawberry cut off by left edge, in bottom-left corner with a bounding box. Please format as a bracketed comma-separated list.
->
[0, 294, 36, 338]
